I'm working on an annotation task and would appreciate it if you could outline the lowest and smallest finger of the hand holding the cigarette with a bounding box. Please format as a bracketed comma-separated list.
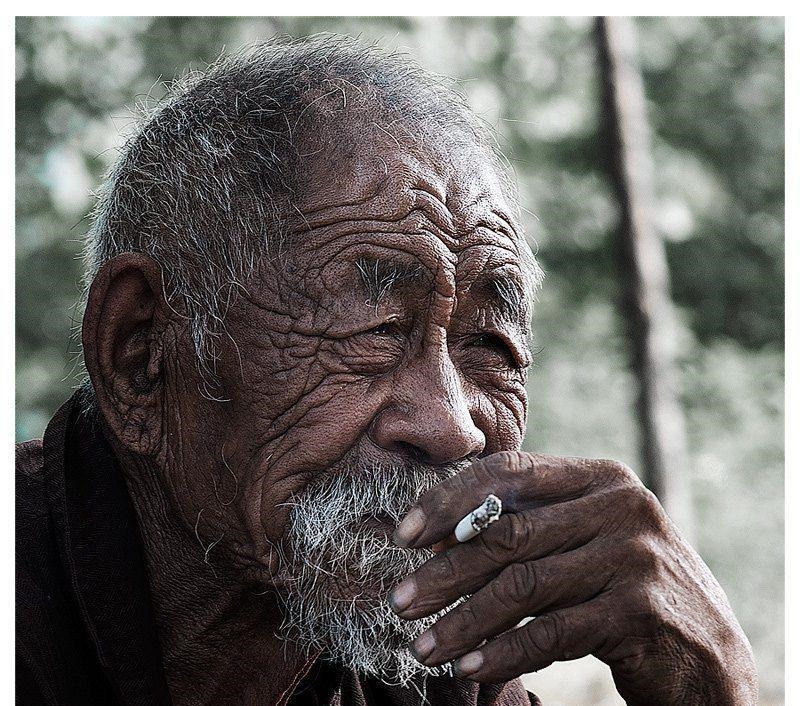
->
[454, 599, 608, 682]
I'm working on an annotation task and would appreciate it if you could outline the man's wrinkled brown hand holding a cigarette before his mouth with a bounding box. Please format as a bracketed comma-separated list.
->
[390, 452, 757, 706]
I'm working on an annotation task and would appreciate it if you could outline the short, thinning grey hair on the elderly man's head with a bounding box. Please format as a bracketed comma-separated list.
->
[85, 35, 515, 390]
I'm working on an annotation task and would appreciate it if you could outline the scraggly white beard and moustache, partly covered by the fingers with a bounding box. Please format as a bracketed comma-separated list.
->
[278, 463, 460, 686]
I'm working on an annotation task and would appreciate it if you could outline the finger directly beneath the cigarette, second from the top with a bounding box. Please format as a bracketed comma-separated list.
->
[389, 491, 617, 619]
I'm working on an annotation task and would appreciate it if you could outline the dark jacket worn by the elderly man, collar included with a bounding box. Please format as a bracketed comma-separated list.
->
[16, 392, 539, 706]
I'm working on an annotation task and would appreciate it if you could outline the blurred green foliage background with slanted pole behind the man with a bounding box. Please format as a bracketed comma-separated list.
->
[16, 17, 784, 706]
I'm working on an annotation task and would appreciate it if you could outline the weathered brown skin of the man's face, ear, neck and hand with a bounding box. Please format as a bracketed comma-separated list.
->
[83, 122, 756, 705]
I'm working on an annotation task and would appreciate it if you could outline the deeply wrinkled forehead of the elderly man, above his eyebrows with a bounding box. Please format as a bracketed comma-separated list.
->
[292, 124, 535, 288]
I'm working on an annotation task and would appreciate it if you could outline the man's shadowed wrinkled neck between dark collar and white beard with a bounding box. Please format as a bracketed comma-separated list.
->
[121, 458, 315, 706]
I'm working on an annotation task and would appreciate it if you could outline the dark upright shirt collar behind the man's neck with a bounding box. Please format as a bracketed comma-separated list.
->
[43, 390, 170, 706]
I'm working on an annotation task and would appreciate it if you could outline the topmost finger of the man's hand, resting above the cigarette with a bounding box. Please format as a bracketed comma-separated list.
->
[394, 451, 638, 548]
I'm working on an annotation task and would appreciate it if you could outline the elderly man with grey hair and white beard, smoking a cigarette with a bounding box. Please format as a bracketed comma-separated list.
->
[17, 38, 757, 706]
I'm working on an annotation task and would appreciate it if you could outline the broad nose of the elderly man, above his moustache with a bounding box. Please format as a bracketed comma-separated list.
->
[371, 356, 486, 465]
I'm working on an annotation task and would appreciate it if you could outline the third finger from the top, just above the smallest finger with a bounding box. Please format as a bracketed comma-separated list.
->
[411, 545, 620, 667]
